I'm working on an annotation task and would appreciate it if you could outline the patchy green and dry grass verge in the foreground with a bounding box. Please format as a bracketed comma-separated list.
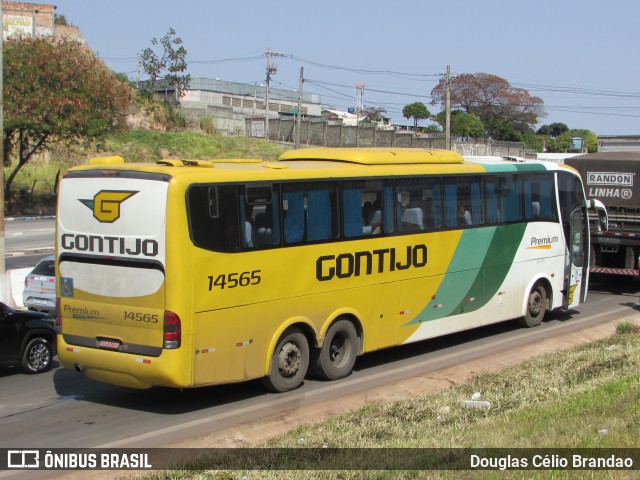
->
[143, 327, 640, 480]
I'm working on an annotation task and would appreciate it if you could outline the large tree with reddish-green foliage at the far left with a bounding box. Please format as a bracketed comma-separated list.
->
[3, 37, 134, 199]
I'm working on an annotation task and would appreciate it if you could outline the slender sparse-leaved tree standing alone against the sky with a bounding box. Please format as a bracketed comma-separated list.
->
[141, 28, 191, 101]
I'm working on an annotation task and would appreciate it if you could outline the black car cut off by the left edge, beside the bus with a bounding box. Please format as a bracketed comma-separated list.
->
[0, 303, 56, 373]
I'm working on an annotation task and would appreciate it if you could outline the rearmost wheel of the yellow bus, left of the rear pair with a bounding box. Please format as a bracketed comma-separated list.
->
[262, 328, 309, 392]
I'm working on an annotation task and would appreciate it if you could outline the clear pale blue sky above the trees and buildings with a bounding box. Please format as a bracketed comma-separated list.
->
[39, 0, 640, 135]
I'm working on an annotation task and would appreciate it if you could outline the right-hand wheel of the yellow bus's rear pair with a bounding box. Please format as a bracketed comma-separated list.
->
[311, 319, 358, 380]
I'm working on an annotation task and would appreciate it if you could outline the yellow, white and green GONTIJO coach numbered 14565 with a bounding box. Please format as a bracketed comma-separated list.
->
[56, 148, 589, 392]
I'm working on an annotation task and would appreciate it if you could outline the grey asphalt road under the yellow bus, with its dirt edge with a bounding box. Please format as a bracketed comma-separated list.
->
[0, 283, 639, 472]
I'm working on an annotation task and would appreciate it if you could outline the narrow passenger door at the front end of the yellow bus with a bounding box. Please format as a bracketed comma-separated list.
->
[563, 207, 590, 308]
